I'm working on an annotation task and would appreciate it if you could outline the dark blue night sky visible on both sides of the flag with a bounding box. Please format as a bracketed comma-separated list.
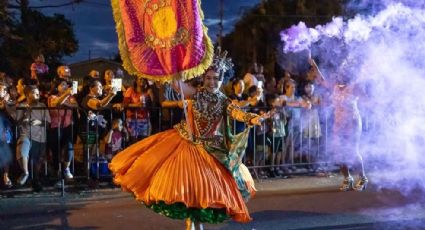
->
[30, 0, 260, 64]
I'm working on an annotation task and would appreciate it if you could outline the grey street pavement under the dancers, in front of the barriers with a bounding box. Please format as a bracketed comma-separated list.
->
[0, 175, 425, 230]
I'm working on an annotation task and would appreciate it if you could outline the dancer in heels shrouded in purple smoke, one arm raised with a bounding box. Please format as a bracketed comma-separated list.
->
[309, 59, 369, 191]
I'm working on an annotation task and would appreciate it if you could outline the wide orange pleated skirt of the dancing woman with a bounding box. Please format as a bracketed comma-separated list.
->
[109, 129, 255, 222]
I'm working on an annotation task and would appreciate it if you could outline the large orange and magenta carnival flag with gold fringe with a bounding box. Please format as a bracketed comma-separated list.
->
[112, 0, 214, 82]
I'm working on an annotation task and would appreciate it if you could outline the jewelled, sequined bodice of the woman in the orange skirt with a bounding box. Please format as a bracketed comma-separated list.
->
[193, 89, 228, 137]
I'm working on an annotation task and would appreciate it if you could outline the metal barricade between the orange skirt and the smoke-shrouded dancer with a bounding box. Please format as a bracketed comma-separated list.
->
[233, 105, 331, 178]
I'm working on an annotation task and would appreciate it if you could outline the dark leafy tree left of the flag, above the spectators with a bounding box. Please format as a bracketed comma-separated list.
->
[0, 0, 78, 76]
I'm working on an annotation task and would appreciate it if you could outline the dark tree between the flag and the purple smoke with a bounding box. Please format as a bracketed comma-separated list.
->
[223, 0, 343, 76]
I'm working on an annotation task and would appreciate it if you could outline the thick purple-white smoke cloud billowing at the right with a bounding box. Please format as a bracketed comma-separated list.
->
[281, 1, 425, 193]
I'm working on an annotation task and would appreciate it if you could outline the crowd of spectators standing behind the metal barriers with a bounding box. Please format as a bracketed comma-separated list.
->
[0, 55, 332, 191]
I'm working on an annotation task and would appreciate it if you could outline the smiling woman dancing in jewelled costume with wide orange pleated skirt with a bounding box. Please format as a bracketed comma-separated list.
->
[109, 57, 269, 228]
